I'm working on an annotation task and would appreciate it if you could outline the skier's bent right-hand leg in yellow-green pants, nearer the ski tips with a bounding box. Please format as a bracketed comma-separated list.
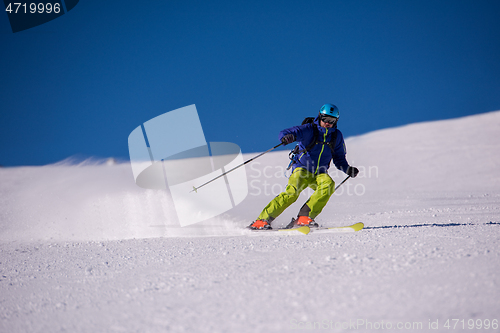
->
[298, 173, 335, 220]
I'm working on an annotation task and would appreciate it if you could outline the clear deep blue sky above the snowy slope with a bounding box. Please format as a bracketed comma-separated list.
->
[0, 0, 500, 166]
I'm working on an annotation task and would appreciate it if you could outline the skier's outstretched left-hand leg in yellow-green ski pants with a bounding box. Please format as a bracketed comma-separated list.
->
[257, 168, 314, 221]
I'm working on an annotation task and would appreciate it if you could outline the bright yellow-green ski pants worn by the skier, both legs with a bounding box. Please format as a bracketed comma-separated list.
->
[258, 168, 335, 221]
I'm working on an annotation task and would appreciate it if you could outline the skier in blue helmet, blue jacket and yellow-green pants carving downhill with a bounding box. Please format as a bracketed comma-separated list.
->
[248, 104, 359, 230]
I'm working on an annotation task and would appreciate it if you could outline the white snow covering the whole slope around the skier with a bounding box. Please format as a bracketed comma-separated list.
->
[0, 111, 500, 333]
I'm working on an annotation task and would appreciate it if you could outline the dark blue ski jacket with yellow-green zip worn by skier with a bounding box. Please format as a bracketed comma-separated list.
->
[279, 117, 349, 174]
